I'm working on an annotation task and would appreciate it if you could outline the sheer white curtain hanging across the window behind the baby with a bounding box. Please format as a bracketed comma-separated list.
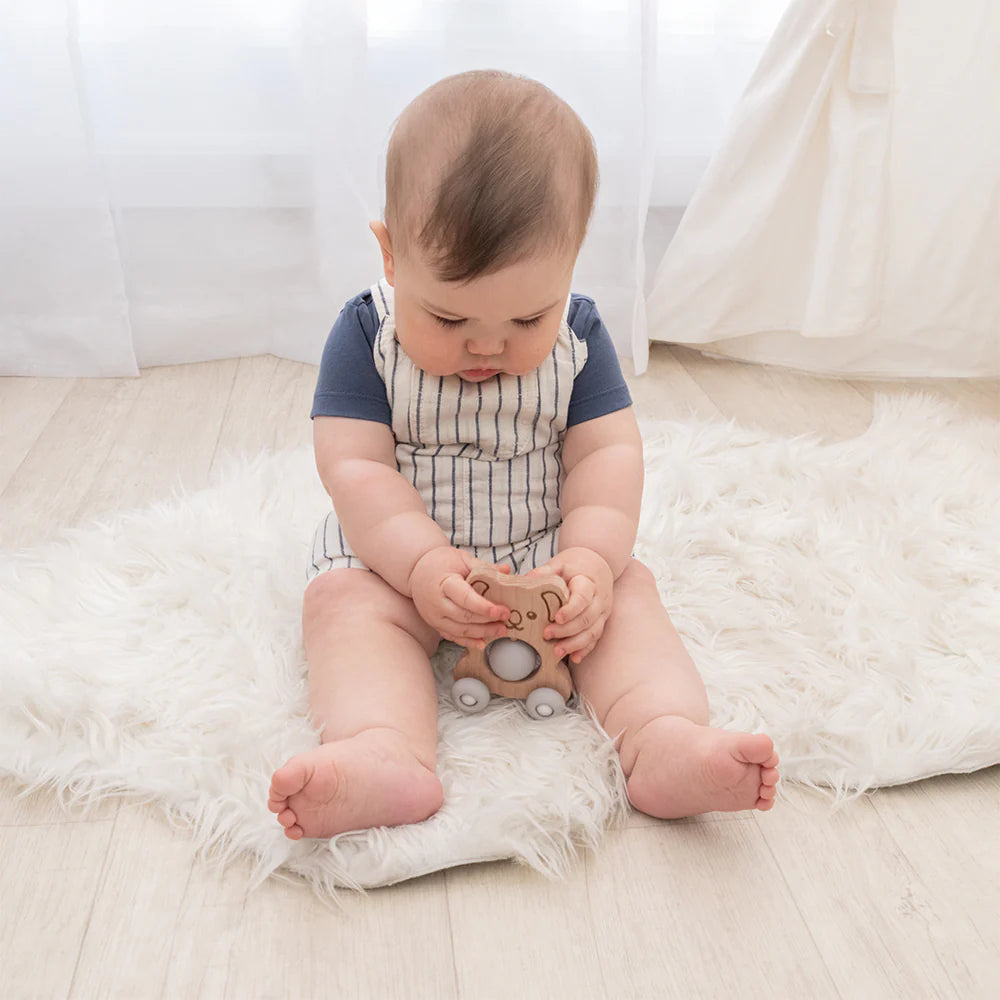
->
[0, 0, 783, 375]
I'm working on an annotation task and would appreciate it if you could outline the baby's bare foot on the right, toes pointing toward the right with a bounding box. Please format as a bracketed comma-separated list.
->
[628, 715, 778, 819]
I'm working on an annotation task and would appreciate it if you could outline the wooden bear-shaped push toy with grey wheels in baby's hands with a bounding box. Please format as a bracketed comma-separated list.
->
[451, 566, 573, 719]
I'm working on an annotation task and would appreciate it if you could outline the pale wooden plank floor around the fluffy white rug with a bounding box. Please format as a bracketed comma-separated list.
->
[0, 345, 1000, 1000]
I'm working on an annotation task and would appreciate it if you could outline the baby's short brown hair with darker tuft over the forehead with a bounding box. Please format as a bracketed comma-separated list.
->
[385, 70, 598, 282]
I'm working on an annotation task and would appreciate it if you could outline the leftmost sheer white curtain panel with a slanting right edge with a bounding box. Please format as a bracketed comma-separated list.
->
[0, 3, 138, 376]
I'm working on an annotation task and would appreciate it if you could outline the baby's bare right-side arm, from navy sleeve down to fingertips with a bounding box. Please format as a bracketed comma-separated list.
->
[536, 407, 643, 663]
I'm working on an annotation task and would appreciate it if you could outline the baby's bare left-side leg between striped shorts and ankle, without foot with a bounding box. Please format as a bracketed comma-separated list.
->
[302, 569, 439, 770]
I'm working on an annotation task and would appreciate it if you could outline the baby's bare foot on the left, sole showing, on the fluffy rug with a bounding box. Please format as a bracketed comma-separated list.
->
[267, 729, 443, 840]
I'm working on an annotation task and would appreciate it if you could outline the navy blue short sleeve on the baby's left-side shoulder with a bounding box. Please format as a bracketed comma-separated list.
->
[310, 291, 392, 427]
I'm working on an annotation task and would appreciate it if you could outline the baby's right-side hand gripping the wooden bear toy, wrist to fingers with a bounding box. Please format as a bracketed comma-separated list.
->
[527, 547, 615, 663]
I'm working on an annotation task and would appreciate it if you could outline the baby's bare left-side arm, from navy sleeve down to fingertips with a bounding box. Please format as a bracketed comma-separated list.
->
[313, 416, 509, 645]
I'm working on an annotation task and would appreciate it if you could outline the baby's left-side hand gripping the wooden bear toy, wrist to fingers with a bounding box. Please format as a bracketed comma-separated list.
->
[410, 545, 510, 649]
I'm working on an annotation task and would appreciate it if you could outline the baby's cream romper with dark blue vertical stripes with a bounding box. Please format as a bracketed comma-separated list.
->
[307, 280, 587, 576]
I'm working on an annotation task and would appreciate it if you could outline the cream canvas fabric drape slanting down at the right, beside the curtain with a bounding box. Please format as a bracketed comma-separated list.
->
[648, 0, 1000, 377]
